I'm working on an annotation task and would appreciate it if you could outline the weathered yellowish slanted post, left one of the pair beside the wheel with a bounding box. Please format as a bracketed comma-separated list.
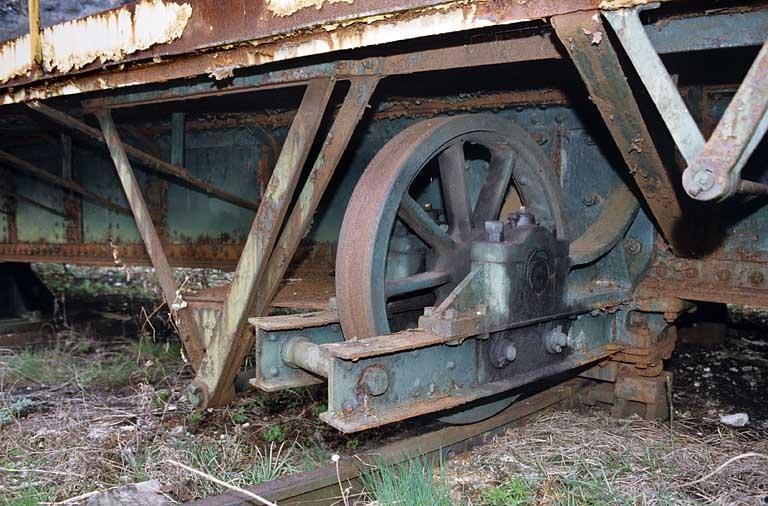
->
[190, 77, 335, 407]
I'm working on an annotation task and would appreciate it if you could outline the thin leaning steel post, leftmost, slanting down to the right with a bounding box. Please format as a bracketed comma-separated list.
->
[96, 110, 205, 370]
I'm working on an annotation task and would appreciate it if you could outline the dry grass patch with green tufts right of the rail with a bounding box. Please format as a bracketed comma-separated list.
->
[448, 412, 768, 506]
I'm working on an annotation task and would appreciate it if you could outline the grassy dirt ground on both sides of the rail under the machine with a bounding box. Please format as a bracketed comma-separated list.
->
[0, 266, 768, 506]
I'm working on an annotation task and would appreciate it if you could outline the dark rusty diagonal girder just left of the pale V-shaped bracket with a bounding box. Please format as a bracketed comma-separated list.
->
[552, 11, 687, 252]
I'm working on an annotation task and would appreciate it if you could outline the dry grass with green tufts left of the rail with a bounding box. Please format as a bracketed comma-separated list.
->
[0, 336, 324, 505]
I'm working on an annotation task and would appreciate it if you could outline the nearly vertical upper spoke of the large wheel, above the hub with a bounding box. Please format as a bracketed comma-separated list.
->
[439, 142, 471, 239]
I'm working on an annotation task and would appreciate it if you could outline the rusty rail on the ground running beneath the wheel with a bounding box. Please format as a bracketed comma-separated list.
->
[188, 379, 592, 506]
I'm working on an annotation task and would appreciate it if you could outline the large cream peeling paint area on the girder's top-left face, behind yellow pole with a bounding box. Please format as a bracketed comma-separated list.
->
[0, 0, 192, 83]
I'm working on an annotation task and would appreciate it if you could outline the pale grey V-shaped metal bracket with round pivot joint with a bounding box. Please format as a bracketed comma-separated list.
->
[603, 3, 768, 201]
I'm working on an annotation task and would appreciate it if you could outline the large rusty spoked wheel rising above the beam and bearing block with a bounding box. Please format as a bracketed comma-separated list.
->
[336, 114, 567, 339]
